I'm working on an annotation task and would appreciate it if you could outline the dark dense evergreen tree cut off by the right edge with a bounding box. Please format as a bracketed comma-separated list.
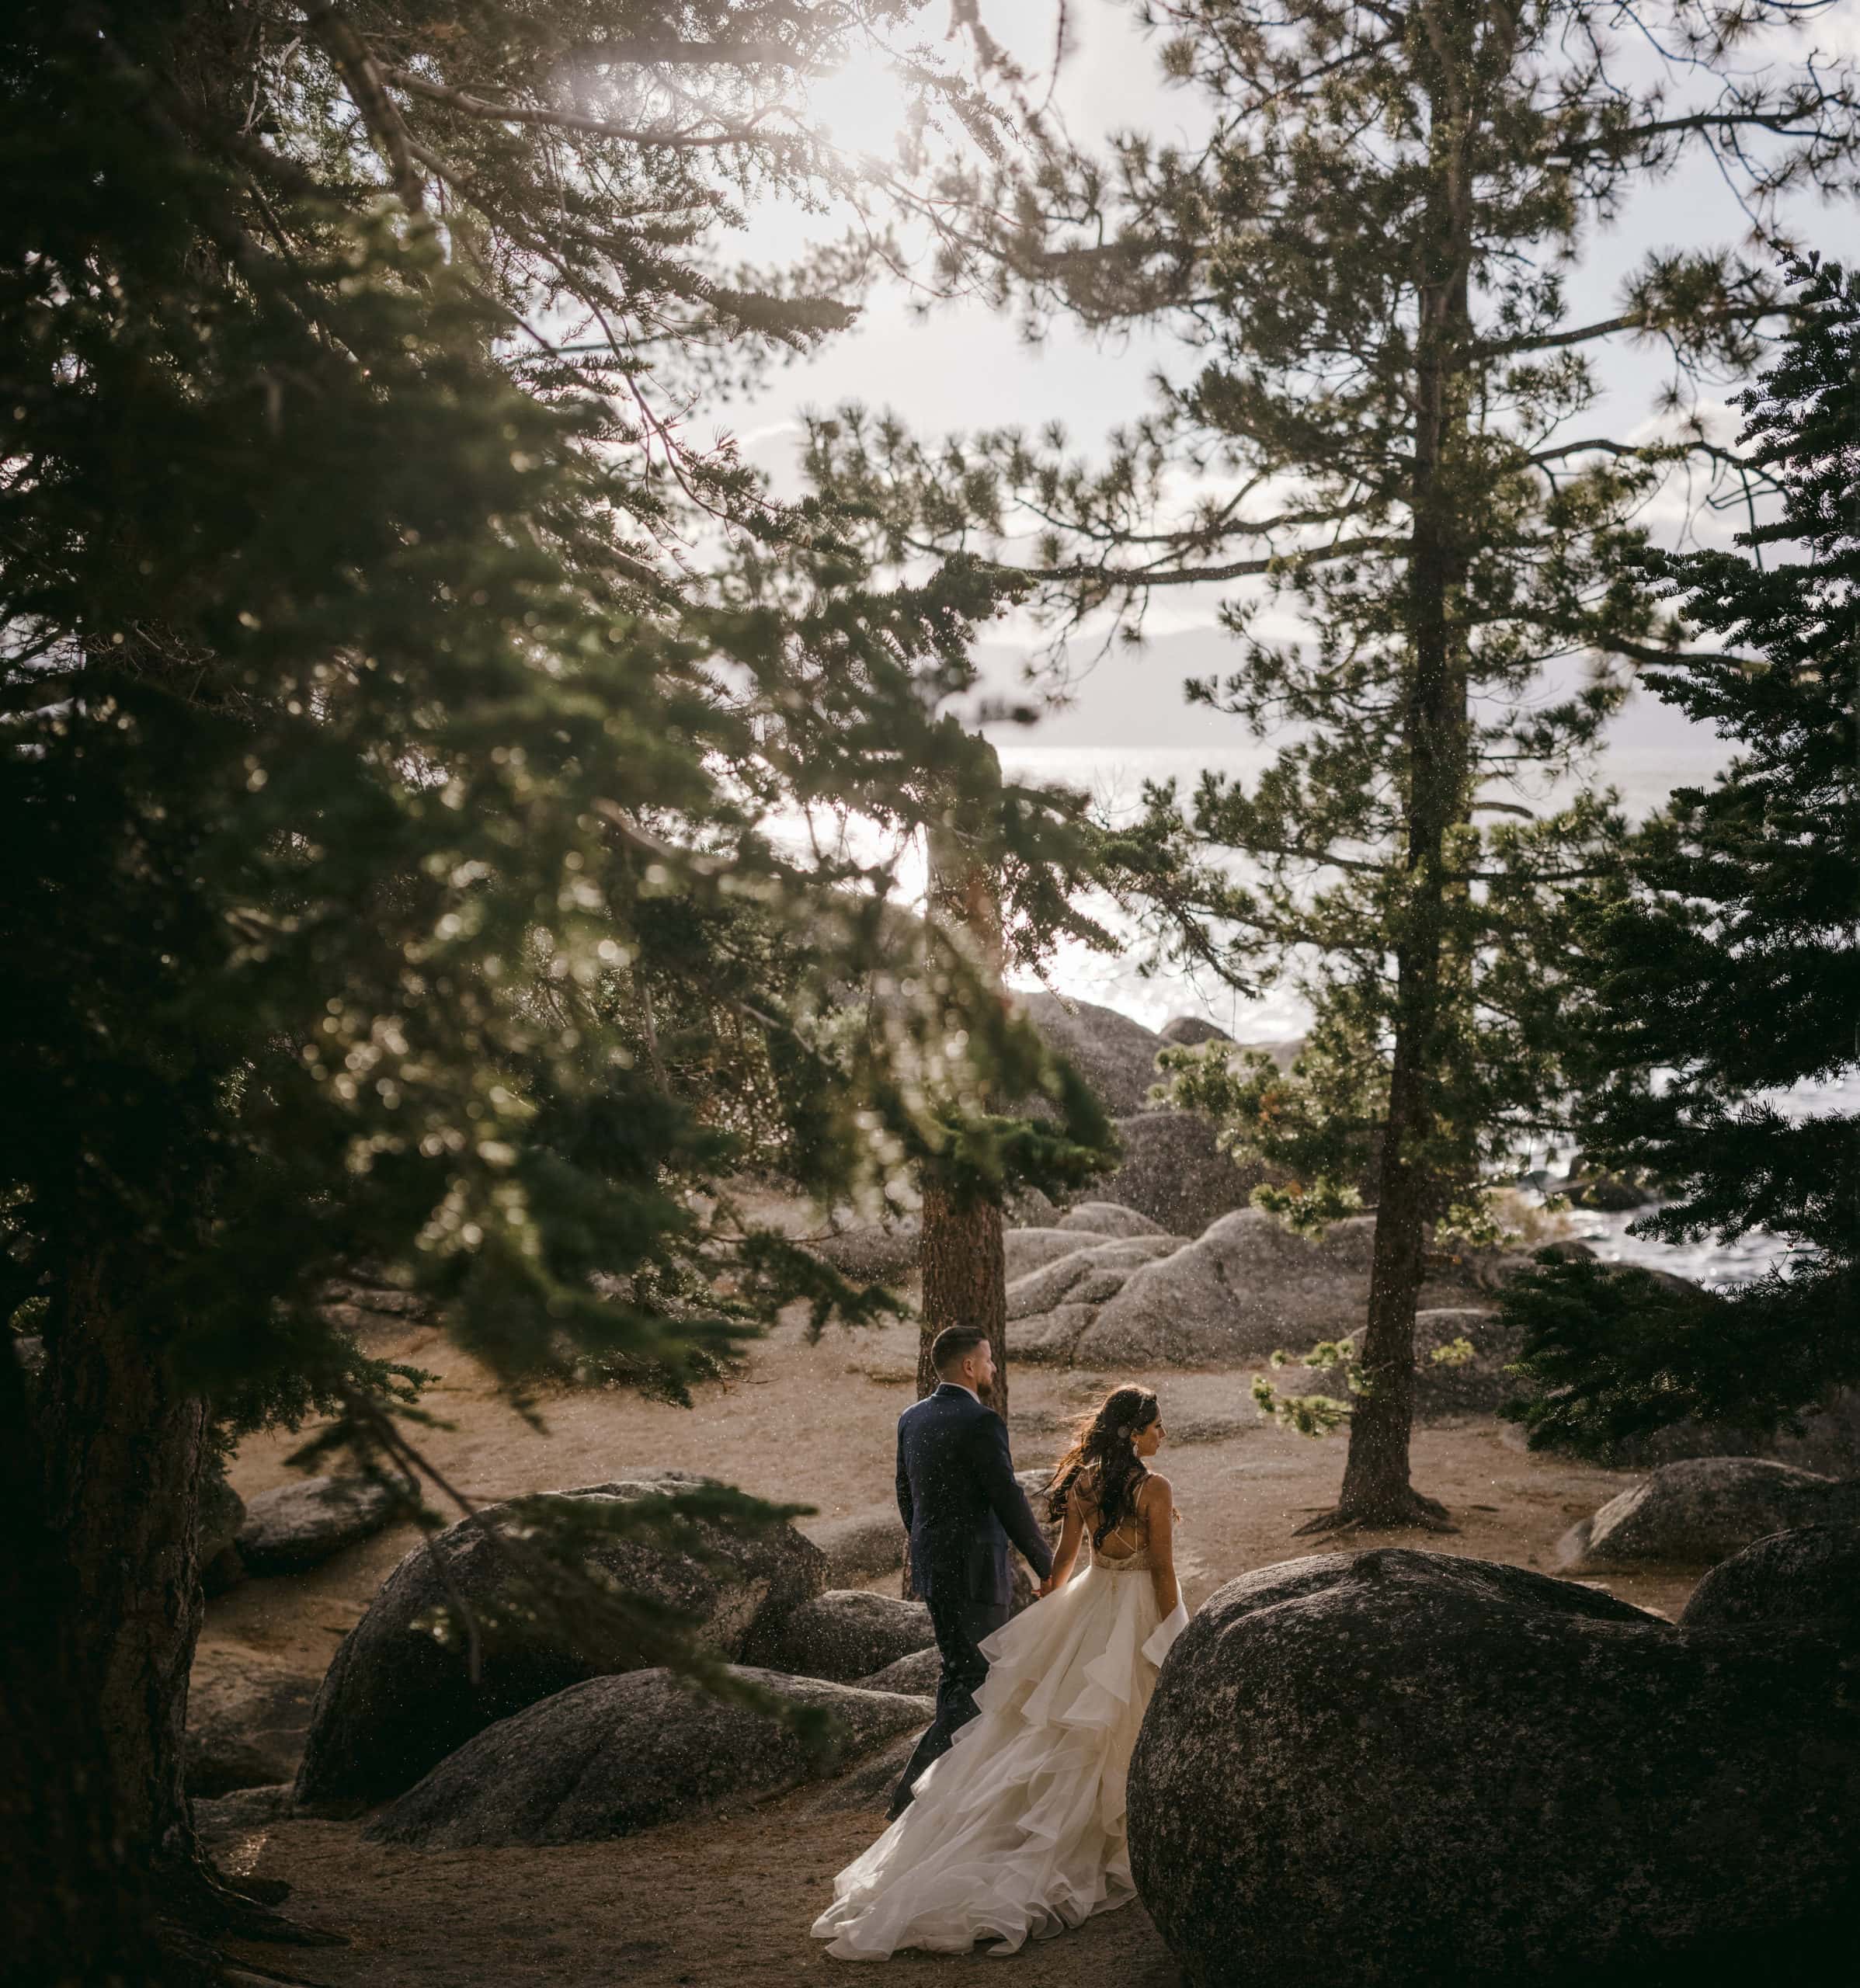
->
[1504, 260, 1860, 1451]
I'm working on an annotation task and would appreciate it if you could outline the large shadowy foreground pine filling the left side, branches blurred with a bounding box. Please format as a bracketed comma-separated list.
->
[0, 12, 1091, 1984]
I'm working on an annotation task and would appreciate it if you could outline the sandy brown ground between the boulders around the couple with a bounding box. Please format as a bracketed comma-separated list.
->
[205, 1326, 1695, 1988]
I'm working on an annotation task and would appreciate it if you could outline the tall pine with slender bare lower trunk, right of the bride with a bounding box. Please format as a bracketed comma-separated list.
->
[811, 0, 1860, 1531]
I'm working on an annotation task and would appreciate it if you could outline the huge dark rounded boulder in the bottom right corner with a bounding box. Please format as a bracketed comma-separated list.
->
[1128, 1548, 1860, 1988]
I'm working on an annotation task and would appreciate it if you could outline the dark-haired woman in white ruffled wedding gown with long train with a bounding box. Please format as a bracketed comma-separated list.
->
[813, 1388, 1188, 1960]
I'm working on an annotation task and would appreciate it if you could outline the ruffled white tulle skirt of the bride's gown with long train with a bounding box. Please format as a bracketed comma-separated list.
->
[813, 1566, 1188, 1960]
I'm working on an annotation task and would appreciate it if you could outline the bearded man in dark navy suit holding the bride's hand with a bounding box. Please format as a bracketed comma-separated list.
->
[888, 1326, 1053, 1821]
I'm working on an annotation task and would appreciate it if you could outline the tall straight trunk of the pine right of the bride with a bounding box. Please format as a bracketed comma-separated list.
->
[1298, 0, 1486, 1533]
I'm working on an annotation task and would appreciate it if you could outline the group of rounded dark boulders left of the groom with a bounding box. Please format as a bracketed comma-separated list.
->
[283, 1471, 934, 1845]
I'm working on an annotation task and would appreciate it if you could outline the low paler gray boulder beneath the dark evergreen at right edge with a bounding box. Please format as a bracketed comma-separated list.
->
[1556, 1457, 1860, 1569]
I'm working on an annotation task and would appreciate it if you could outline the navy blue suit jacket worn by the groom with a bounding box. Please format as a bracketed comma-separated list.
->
[899, 1382, 1053, 1606]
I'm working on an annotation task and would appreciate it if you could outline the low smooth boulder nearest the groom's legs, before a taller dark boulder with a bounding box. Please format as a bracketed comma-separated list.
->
[367, 1670, 932, 1849]
